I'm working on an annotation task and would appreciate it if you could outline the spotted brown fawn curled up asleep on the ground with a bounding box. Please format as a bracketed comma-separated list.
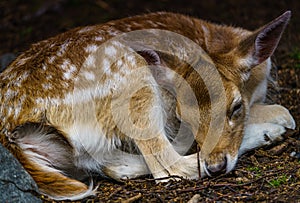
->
[0, 11, 295, 200]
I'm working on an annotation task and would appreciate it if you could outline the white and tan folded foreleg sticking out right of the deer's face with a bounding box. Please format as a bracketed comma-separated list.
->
[239, 104, 296, 155]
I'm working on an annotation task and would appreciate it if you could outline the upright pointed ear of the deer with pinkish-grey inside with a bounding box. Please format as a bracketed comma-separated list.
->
[236, 11, 291, 68]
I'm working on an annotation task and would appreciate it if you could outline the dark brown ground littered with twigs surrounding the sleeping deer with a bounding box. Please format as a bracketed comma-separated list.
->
[0, 0, 300, 202]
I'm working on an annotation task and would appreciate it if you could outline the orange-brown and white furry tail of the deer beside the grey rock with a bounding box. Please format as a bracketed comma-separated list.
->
[8, 123, 95, 200]
